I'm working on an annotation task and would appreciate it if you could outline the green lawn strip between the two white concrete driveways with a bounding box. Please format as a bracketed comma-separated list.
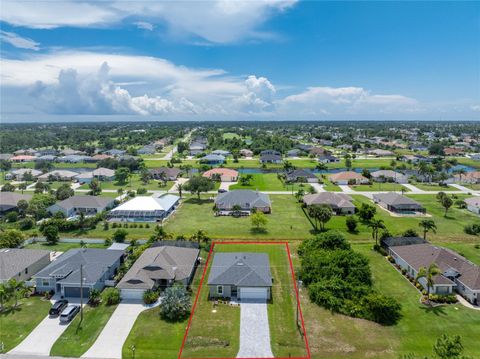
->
[50, 304, 117, 358]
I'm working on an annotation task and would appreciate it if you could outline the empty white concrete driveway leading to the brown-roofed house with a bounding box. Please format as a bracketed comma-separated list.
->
[82, 300, 159, 359]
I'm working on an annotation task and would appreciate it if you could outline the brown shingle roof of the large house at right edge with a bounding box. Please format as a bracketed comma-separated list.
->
[390, 243, 480, 290]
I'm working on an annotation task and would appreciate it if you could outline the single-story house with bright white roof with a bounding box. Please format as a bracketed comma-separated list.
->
[109, 194, 180, 222]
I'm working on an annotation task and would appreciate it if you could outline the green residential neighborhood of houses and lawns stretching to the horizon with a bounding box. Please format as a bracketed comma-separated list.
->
[0, 122, 480, 359]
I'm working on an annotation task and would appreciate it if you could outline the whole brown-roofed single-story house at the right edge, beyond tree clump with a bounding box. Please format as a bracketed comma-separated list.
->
[388, 243, 480, 304]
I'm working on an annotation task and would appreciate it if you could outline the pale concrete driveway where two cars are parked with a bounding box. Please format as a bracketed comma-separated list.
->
[9, 298, 80, 356]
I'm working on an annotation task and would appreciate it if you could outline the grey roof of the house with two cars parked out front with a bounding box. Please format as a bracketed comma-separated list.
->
[34, 248, 124, 284]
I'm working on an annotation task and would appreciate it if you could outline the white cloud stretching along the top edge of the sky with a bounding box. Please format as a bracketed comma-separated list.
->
[0, 0, 297, 43]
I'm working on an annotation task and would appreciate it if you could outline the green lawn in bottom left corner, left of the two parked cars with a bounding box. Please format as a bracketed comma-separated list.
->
[0, 296, 51, 352]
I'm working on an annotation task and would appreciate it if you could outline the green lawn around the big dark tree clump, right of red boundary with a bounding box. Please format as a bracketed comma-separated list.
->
[292, 243, 480, 359]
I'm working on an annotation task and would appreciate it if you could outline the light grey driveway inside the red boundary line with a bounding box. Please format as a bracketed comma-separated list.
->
[237, 300, 274, 358]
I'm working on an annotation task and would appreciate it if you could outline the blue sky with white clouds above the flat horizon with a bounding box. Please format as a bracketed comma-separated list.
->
[0, 0, 480, 122]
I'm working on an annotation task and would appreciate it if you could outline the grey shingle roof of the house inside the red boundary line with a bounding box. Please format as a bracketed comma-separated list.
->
[208, 252, 272, 287]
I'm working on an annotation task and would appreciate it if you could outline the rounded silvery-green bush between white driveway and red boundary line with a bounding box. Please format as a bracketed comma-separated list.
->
[160, 285, 191, 321]
